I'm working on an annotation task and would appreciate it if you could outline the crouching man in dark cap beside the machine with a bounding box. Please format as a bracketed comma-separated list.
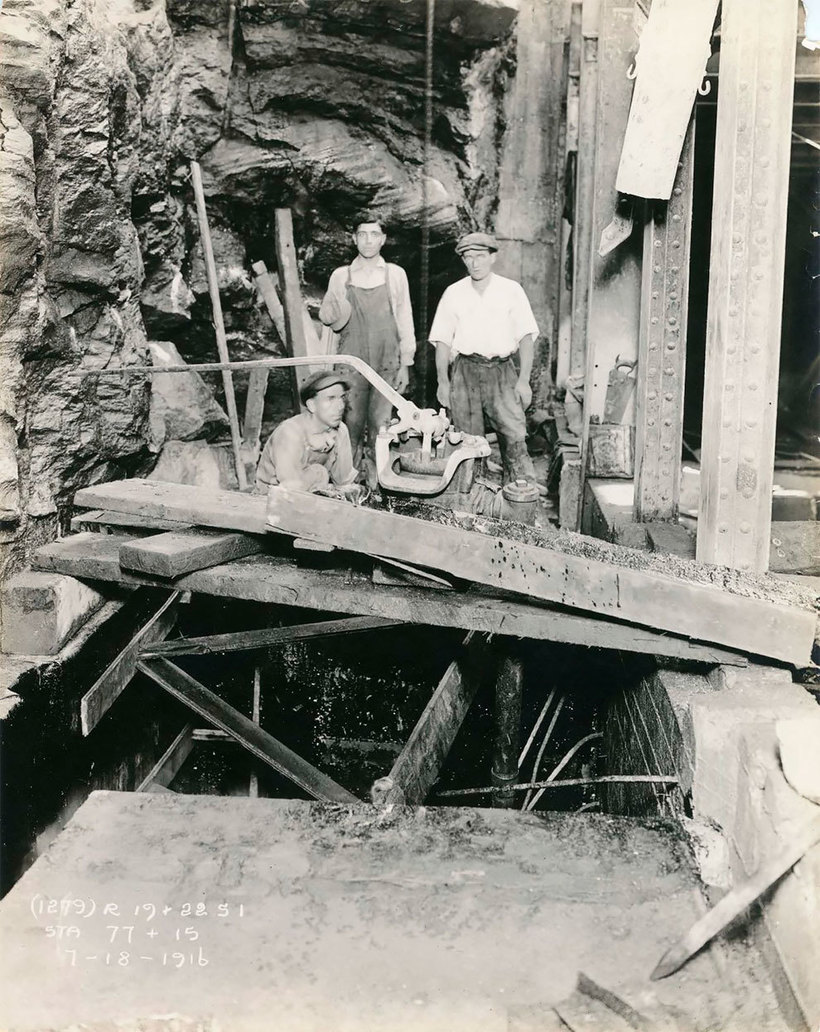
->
[256, 372, 365, 502]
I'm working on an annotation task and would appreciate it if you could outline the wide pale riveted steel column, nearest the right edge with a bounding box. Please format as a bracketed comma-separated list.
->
[697, 0, 797, 571]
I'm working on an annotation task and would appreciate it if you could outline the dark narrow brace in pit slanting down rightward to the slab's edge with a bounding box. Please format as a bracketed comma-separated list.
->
[137, 658, 359, 803]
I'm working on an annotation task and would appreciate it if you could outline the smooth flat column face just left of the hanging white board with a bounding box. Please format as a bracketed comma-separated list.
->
[580, 0, 643, 528]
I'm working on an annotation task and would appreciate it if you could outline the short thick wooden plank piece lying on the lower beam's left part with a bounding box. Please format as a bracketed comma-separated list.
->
[120, 528, 264, 578]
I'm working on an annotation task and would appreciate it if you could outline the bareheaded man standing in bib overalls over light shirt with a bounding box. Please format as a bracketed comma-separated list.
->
[319, 214, 416, 487]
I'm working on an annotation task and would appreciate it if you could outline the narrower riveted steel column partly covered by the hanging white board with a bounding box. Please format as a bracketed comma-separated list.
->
[634, 123, 694, 521]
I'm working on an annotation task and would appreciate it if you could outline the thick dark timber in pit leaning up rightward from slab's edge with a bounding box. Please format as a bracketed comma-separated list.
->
[380, 634, 487, 806]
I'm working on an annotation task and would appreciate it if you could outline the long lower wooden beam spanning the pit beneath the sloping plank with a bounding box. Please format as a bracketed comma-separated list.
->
[33, 534, 747, 666]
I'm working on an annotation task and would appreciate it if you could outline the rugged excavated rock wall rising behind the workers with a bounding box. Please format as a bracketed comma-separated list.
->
[0, 0, 517, 576]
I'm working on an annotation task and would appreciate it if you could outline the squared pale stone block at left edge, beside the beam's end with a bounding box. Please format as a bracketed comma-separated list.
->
[0, 571, 105, 655]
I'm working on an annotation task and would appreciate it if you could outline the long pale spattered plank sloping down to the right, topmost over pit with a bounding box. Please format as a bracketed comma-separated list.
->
[268, 487, 815, 664]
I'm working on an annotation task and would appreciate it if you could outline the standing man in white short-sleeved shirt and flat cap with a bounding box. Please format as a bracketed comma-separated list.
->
[430, 233, 538, 483]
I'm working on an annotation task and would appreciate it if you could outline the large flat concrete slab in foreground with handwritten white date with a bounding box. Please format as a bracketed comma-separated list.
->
[0, 793, 783, 1032]
